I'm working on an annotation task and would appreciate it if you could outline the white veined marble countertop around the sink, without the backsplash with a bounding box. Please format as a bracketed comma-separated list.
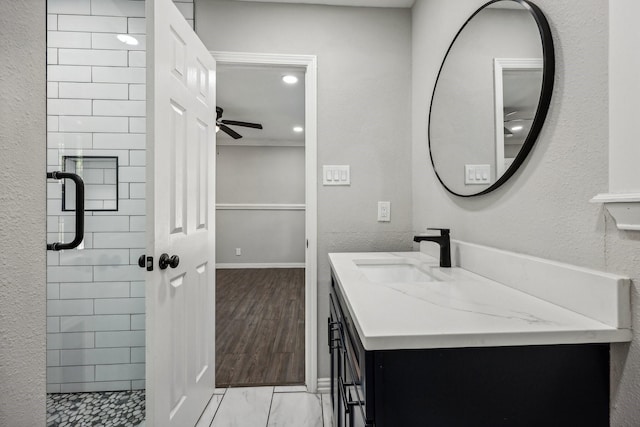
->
[329, 252, 631, 350]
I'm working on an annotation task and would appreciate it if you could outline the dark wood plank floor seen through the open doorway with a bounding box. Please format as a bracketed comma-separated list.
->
[216, 268, 304, 387]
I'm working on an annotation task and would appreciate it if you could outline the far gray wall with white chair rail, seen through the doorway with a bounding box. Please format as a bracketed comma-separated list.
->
[216, 145, 305, 268]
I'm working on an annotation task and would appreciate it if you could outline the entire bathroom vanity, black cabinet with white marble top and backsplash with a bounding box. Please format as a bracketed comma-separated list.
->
[328, 249, 631, 427]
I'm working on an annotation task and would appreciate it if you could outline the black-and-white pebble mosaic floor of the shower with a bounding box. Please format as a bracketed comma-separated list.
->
[47, 390, 145, 427]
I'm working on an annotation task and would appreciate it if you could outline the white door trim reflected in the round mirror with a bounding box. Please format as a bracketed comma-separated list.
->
[493, 58, 543, 177]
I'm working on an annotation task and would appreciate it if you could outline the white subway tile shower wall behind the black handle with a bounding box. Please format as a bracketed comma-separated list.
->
[47, 0, 194, 393]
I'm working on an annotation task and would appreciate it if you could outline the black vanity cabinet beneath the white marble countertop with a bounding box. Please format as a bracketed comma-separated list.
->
[328, 278, 609, 427]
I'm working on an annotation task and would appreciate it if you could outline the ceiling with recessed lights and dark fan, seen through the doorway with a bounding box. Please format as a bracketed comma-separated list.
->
[216, 64, 305, 145]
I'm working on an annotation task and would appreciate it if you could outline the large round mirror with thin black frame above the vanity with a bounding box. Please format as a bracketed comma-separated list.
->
[429, 0, 555, 197]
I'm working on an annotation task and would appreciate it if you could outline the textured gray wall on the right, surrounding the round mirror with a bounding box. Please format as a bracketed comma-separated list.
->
[412, 0, 640, 426]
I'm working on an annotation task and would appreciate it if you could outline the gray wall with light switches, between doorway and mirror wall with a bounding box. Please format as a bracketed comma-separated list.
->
[196, 0, 412, 378]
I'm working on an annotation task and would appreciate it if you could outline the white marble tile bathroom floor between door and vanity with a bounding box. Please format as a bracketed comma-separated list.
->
[138, 386, 333, 427]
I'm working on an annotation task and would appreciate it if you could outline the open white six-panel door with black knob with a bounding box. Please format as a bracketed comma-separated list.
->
[146, 0, 216, 427]
